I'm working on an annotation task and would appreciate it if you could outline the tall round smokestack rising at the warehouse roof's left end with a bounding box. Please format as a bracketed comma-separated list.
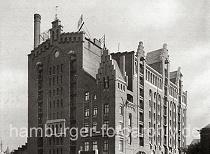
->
[34, 14, 41, 49]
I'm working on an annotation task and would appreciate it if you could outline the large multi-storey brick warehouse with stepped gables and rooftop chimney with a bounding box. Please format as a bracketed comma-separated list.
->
[27, 14, 187, 154]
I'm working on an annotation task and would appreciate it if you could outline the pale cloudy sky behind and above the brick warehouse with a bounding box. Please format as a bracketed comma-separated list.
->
[0, 0, 210, 152]
